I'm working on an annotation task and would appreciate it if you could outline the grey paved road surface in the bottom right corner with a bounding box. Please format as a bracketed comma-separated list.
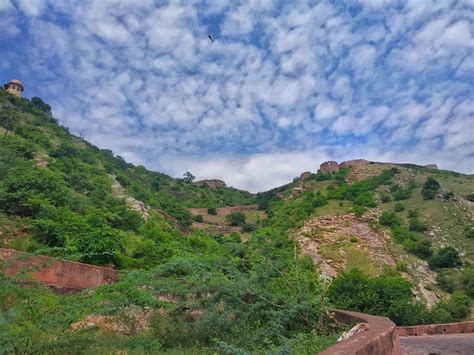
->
[400, 333, 474, 355]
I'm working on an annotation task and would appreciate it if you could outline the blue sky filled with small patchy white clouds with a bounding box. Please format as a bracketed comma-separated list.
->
[0, 0, 474, 192]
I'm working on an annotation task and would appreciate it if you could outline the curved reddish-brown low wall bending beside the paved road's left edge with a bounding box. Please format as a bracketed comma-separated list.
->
[320, 310, 401, 355]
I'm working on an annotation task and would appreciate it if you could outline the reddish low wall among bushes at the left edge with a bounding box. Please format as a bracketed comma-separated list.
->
[0, 248, 118, 293]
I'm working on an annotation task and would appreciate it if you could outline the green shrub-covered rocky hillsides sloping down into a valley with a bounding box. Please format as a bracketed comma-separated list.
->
[0, 90, 474, 354]
